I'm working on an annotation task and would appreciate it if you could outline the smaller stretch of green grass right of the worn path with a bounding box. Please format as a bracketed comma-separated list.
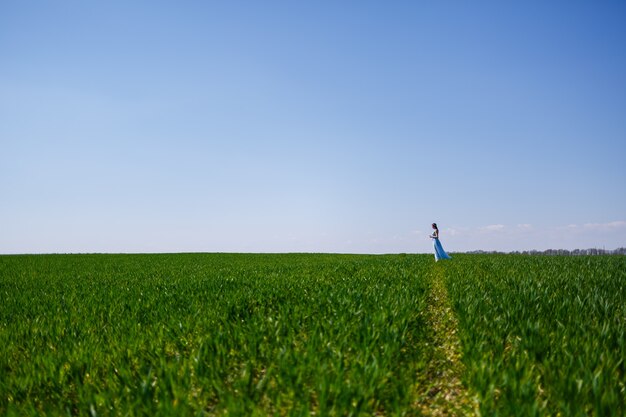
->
[447, 255, 626, 416]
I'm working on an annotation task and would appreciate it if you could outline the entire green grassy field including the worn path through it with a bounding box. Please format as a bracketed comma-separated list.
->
[0, 254, 626, 416]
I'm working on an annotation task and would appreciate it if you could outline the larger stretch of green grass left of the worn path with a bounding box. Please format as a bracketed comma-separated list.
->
[0, 254, 428, 415]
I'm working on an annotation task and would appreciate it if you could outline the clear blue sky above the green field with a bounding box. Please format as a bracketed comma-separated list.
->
[0, 1, 626, 253]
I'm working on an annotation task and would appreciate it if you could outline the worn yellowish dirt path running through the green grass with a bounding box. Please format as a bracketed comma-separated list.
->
[417, 264, 477, 416]
